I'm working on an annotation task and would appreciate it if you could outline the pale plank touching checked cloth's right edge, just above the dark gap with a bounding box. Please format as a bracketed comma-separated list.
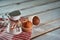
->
[32, 20, 60, 38]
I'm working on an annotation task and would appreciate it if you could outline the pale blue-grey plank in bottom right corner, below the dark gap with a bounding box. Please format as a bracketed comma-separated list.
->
[33, 29, 60, 40]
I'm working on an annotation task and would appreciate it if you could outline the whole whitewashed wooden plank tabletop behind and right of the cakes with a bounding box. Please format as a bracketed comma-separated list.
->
[0, 0, 60, 40]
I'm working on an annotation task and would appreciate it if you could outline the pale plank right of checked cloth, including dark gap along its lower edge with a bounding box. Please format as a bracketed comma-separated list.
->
[31, 19, 60, 39]
